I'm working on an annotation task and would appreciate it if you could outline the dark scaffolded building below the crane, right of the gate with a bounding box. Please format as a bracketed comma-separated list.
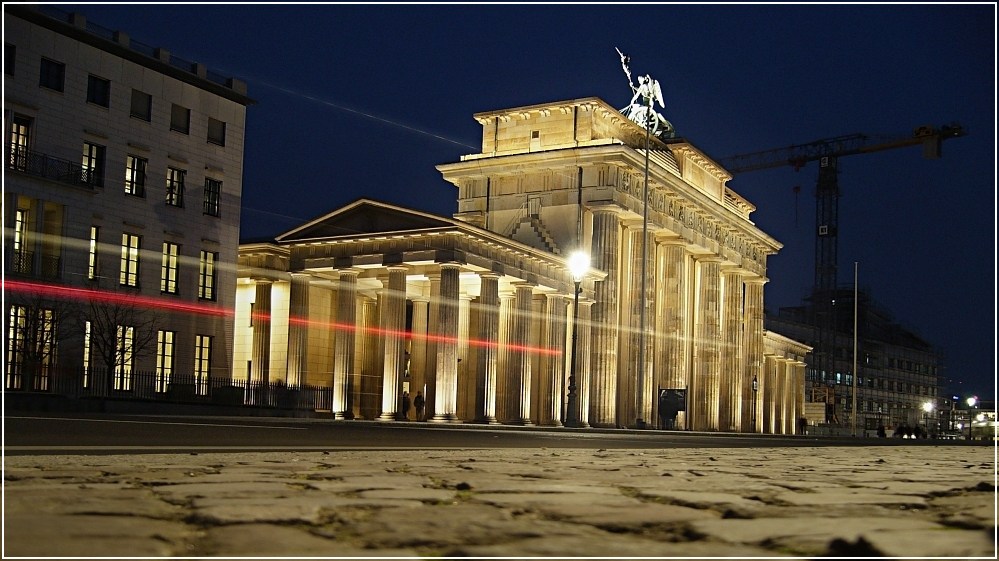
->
[766, 287, 951, 434]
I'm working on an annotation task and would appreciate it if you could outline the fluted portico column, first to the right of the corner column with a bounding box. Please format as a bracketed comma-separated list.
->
[473, 273, 499, 424]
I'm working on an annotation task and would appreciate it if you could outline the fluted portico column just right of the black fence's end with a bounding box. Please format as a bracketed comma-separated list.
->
[332, 269, 359, 419]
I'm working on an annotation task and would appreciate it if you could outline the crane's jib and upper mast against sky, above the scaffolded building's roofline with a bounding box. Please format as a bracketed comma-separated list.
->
[719, 124, 967, 293]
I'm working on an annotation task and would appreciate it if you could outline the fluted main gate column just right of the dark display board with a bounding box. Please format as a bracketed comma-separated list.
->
[692, 257, 721, 430]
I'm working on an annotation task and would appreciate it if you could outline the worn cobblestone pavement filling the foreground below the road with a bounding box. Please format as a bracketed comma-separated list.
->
[3, 446, 996, 559]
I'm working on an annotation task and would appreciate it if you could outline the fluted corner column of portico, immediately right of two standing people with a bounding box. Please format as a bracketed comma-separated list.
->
[431, 263, 460, 423]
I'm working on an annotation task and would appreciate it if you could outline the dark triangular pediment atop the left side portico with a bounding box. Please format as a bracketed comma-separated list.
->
[277, 199, 454, 242]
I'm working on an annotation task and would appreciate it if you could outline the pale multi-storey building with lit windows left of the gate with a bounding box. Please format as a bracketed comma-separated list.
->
[3, 4, 252, 396]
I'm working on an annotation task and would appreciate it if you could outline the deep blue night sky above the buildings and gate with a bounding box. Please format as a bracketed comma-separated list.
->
[54, 4, 996, 398]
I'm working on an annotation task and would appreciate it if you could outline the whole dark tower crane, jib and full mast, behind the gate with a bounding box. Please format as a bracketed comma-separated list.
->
[719, 124, 967, 424]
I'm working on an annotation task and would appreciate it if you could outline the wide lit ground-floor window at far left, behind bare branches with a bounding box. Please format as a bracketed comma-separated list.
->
[6, 305, 55, 391]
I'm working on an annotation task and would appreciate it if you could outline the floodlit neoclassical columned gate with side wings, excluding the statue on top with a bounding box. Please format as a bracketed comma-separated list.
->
[233, 98, 809, 434]
